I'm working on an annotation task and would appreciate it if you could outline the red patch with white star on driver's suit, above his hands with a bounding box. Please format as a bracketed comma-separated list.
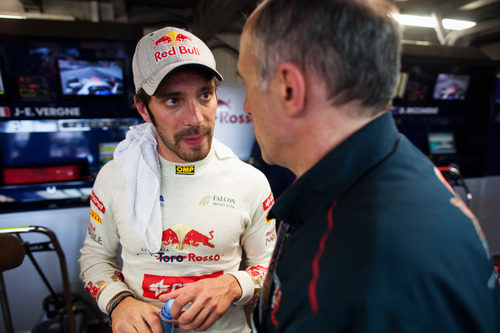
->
[142, 271, 224, 299]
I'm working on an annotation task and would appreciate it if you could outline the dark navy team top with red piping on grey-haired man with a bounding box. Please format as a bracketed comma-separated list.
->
[253, 114, 500, 333]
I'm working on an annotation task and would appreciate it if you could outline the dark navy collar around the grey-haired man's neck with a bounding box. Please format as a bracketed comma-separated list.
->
[271, 112, 400, 224]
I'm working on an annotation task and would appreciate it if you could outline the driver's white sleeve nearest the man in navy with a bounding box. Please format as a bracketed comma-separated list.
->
[230, 172, 276, 305]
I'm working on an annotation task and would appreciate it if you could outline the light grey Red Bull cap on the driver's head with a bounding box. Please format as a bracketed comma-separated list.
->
[132, 27, 222, 95]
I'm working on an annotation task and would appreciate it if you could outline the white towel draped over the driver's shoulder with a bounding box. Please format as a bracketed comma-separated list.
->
[113, 123, 162, 252]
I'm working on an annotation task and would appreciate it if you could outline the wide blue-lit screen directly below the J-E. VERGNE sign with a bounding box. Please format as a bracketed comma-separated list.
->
[0, 118, 139, 178]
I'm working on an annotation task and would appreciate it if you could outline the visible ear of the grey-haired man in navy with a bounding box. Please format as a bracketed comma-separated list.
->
[277, 62, 306, 117]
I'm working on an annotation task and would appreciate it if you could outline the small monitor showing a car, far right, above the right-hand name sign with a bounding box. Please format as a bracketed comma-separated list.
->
[433, 73, 470, 100]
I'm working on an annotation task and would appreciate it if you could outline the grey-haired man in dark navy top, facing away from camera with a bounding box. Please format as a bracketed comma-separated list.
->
[238, 0, 500, 333]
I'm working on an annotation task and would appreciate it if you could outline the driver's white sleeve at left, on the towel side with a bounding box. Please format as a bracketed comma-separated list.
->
[78, 162, 133, 312]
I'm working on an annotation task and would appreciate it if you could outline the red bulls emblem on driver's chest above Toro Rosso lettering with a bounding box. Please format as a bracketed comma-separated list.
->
[161, 224, 215, 250]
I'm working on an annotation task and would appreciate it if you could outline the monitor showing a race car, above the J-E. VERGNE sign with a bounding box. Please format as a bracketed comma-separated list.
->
[57, 58, 124, 96]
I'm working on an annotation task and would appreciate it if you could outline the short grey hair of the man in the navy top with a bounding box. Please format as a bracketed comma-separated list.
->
[248, 0, 401, 113]
